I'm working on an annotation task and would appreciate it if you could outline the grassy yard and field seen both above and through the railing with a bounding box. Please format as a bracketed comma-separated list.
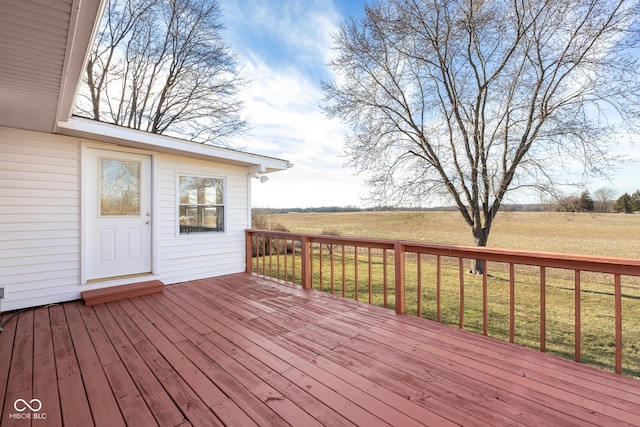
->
[252, 212, 640, 377]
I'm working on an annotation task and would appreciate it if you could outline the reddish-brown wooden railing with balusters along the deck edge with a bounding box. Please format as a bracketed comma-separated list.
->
[246, 230, 640, 376]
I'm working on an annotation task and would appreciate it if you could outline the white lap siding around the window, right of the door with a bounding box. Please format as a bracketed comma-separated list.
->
[156, 155, 249, 284]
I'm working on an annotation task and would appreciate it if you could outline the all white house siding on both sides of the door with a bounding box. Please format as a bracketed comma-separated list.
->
[0, 128, 255, 312]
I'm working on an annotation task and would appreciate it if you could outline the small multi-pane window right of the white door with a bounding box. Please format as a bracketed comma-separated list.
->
[178, 175, 224, 234]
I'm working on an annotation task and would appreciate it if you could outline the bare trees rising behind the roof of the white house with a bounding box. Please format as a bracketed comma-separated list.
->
[76, 0, 246, 143]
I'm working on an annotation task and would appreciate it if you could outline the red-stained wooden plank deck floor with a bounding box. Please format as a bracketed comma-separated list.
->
[0, 274, 640, 427]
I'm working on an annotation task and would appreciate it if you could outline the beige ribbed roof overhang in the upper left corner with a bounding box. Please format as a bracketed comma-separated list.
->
[0, 0, 106, 132]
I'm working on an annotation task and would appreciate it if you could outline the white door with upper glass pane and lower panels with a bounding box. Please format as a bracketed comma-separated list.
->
[84, 148, 152, 280]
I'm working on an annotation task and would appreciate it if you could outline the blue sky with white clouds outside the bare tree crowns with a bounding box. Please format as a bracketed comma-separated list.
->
[220, 0, 640, 208]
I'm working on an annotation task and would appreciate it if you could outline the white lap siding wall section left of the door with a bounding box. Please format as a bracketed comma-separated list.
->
[0, 128, 80, 311]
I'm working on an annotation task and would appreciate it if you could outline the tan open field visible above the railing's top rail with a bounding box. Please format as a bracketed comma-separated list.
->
[273, 212, 640, 258]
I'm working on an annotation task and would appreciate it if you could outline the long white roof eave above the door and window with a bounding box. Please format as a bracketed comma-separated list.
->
[57, 117, 293, 173]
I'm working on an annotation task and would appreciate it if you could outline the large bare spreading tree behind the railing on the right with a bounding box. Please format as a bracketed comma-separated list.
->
[323, 0, 640, 271]
